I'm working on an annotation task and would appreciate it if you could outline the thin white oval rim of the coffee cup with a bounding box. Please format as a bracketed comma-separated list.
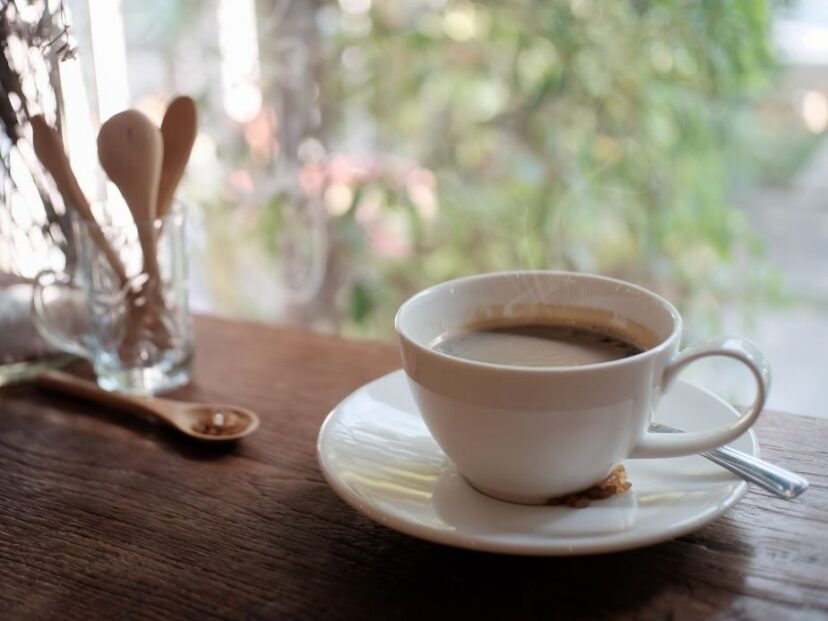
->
[394, 270, 682, 374]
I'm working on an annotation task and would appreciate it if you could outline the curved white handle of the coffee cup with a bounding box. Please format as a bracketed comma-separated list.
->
[630, 337, 770, 458]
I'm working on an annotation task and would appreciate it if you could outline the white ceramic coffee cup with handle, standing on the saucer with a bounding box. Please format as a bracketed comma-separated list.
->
[395, 271, 770, 504]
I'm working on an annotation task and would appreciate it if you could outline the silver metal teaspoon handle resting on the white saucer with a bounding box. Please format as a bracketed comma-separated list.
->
[650, 423, 808, 500]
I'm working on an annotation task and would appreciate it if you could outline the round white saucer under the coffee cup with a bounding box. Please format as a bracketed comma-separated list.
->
[317, 371, 759, 555]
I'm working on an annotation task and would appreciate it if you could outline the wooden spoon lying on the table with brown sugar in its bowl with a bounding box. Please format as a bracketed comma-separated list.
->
[37, 371, 259, 442]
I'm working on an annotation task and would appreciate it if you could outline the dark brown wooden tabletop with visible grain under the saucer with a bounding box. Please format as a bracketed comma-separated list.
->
[0, 318, 828, 621]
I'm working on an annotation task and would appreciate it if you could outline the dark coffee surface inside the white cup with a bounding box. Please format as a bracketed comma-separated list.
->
[432, 314, 656, 367]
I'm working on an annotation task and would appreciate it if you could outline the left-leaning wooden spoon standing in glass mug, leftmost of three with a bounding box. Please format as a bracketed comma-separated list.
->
[30, 114, 127, 288]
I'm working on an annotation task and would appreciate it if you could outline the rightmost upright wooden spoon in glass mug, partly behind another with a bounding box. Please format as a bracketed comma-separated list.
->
[156, 96, 198, 219]
